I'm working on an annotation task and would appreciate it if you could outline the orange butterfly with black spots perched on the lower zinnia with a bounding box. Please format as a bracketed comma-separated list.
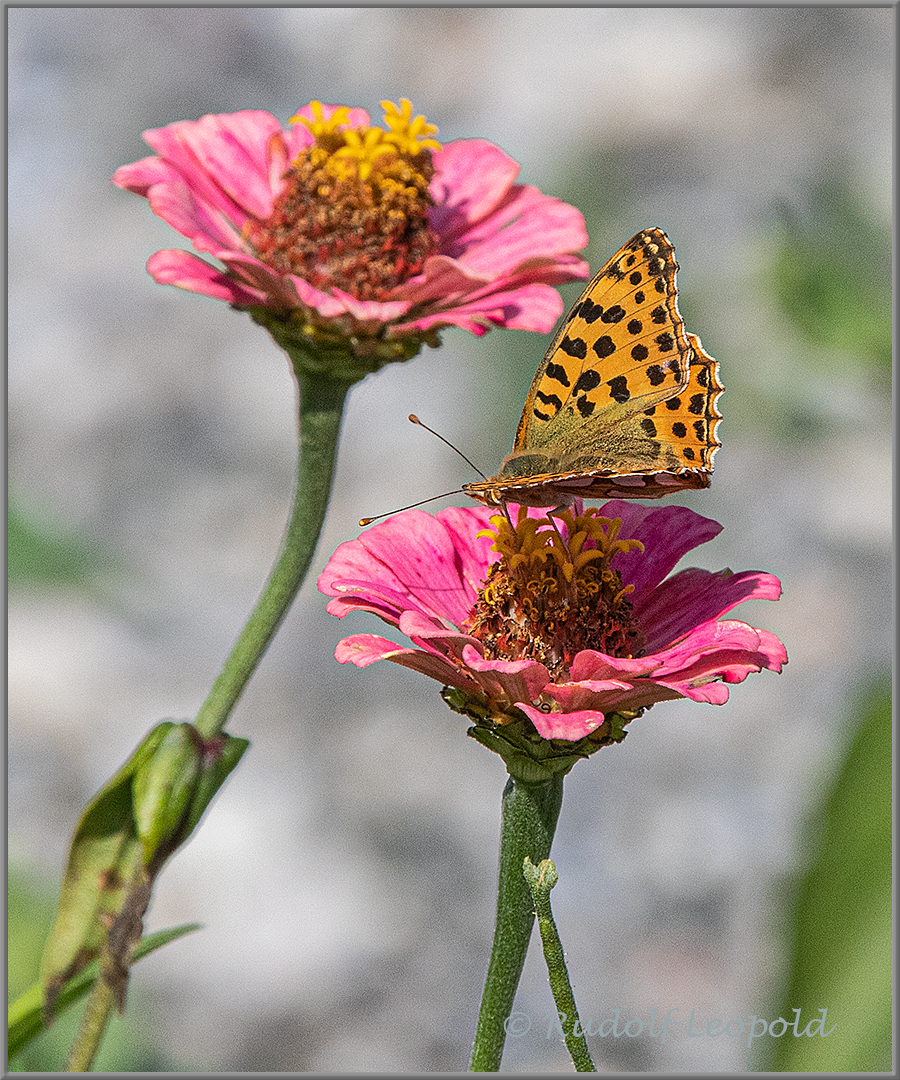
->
[462, 229, 724, 508]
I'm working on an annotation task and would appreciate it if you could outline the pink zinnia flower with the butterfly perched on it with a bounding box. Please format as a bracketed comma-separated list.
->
[319, 500, 788, 753]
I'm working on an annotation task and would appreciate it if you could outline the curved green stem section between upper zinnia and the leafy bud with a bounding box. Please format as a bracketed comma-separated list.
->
[194, 373, 351, 739]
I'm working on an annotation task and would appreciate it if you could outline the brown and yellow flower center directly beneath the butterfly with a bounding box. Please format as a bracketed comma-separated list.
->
[464, 507, 646, 681]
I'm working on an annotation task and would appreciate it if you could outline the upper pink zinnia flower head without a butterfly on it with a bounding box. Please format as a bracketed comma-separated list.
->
[113, 100, 588, 345]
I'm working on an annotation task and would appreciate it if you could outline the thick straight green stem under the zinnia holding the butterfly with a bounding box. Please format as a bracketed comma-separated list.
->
[469, 774, 563, 1072]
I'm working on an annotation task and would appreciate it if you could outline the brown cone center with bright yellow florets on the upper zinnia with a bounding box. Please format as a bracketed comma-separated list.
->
[244, 98, 441, 300]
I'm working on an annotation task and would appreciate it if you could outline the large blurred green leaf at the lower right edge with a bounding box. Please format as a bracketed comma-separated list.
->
[763, 689, 892, 1072]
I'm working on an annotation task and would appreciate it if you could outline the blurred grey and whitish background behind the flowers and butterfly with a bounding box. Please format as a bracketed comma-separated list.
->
[8, 6, 894, 1072]
